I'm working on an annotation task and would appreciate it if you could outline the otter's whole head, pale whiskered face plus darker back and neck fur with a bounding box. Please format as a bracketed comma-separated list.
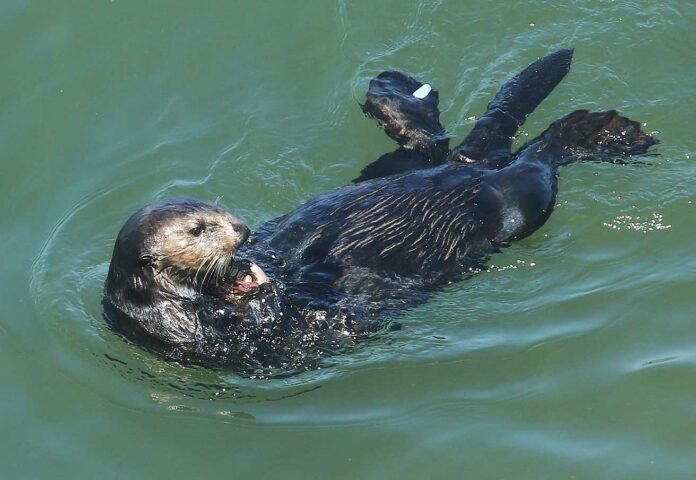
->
[106, 199, 249, 302]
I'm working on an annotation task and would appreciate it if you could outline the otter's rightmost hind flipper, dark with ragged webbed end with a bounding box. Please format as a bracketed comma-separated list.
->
[518, 110, 660, 165]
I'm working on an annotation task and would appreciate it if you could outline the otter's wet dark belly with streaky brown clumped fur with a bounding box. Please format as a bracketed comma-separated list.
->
[267, 163, 524, 283]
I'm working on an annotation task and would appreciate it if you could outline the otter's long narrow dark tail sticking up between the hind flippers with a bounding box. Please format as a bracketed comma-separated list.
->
[448, 49, 573, 168]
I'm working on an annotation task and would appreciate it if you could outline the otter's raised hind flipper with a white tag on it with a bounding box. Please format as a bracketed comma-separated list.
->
[353, 71, 449, 182]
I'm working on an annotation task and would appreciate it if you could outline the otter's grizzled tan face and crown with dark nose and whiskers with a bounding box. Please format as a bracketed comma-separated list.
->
[112, 199, 249, 288]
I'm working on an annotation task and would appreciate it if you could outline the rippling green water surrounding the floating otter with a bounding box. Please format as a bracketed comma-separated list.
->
[0, 0, 696, 480]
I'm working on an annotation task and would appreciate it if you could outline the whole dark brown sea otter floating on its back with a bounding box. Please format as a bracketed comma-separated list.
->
[104, 50, 657, 373]
